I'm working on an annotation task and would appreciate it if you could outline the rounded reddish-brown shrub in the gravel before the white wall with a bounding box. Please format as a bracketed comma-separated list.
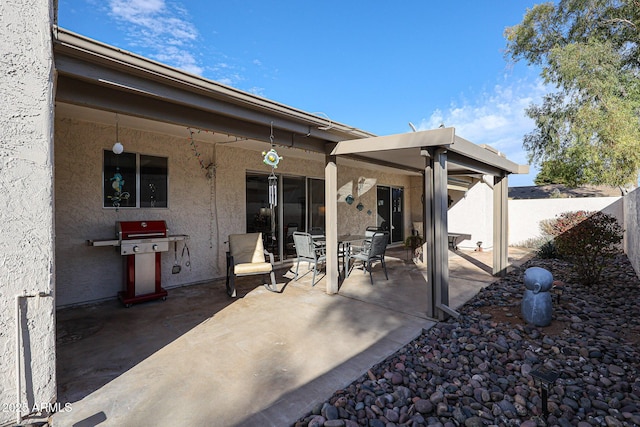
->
[552, 211, 623, 284]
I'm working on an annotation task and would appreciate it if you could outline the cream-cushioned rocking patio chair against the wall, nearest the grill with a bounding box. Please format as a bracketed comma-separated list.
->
[227, 233, 278, 297]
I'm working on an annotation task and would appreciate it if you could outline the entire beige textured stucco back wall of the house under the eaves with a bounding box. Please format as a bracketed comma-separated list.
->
[55, 116, 410, 307]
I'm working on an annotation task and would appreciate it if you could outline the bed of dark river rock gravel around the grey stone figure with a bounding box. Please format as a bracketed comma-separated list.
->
[294, 255, 640, 427]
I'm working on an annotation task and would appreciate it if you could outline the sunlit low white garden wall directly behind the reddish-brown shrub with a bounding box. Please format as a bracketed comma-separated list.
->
[509, 197, 624, 246]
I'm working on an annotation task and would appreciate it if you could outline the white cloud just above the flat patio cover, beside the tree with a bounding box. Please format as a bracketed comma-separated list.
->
[418, 80, 551, 185]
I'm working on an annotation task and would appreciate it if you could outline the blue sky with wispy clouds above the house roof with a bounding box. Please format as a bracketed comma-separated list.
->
[58, 0, 548, 186]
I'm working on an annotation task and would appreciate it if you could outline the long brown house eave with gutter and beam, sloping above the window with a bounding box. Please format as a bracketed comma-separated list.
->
[53, 26, 373, 153]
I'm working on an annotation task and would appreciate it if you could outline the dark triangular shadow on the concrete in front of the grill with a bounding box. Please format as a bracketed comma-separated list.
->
[56, 276, 285, 404]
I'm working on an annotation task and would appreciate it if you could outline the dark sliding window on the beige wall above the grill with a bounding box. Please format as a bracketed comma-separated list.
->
[102, 150, 168, 208]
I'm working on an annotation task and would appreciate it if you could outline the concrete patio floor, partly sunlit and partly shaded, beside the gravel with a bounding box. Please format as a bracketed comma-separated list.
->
[51, 248, 528, 427]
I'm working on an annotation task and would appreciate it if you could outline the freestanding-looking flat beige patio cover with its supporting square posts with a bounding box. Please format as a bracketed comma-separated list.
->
[325, 127, 529, 319]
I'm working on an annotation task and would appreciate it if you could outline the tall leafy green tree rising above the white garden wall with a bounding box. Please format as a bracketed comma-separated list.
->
[505, 0, 640, 186]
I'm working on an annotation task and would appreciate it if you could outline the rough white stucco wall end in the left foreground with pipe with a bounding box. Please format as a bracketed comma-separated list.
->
[0, 0, 56, 425]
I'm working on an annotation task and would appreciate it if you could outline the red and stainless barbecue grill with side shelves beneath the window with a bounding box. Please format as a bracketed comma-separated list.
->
[88, 221, 189, 307]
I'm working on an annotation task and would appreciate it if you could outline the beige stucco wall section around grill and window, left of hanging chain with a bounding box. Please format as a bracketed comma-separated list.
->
[55, 116, 222, 306]
